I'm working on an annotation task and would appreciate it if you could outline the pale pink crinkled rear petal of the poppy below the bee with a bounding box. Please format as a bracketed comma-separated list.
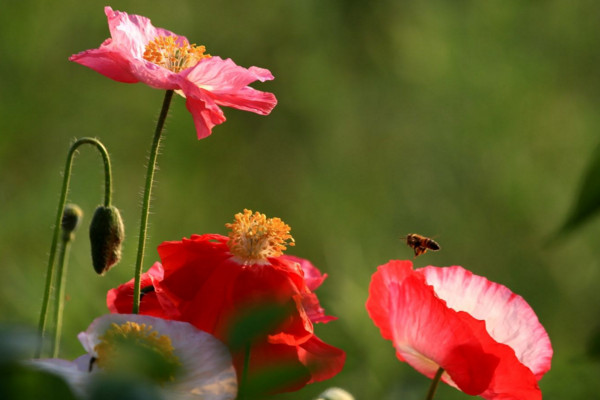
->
[417, 266, 552, 380]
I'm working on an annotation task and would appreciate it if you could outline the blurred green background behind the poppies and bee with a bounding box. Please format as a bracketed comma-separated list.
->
[0, 0, 600, 399]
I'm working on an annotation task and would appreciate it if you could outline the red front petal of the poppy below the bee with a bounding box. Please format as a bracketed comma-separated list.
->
[367, 261, 541, 400]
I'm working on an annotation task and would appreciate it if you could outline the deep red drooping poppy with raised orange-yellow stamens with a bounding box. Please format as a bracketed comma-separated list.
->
[107, 210, 345, 392]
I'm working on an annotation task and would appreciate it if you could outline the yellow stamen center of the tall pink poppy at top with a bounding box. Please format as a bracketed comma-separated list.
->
[143, 36, 210, 73]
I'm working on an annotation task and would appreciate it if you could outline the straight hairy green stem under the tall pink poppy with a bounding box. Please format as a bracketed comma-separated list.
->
[132, 90, 173, 314]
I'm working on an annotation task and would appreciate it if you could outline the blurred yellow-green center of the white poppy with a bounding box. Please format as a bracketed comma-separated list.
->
[94, 321, 181, 384]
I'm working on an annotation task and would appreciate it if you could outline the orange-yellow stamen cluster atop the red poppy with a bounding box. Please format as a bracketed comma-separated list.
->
[225, 210, 294, 264]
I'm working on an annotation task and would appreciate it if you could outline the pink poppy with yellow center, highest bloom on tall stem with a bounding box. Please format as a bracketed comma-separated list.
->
[69, 7, 277, 139]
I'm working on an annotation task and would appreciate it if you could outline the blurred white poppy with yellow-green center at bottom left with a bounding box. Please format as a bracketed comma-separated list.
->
[28, 314, 237, 400]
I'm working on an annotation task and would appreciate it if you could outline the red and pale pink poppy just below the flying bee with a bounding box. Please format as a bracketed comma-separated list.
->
[366, 261, 552, 400]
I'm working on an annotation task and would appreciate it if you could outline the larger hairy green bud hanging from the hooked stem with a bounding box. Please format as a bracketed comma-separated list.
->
[90, 206, 125, 275]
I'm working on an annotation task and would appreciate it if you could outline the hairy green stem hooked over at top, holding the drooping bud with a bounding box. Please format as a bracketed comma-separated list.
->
[35, 137, 112, 358]
